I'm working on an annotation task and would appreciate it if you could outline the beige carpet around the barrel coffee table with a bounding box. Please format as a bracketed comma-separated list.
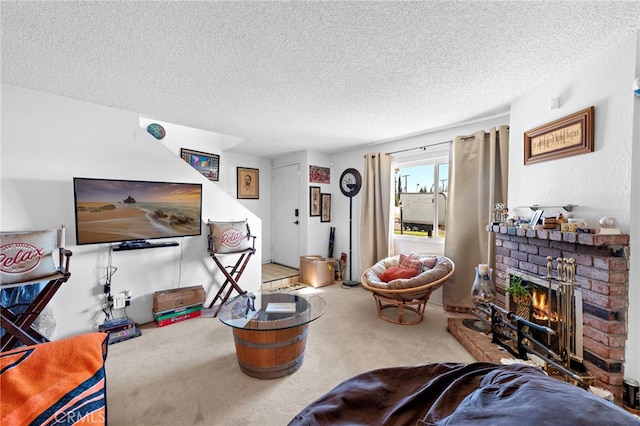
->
[106, 285, 474, 426]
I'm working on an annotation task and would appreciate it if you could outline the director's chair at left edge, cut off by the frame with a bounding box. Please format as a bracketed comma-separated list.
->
[0, 227, 72, 351]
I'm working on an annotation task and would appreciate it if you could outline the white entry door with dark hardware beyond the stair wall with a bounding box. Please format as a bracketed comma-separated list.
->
[271, 164, 300, 269]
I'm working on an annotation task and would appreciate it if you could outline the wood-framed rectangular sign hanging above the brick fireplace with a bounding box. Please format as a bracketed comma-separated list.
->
[524, 106, 594, 164]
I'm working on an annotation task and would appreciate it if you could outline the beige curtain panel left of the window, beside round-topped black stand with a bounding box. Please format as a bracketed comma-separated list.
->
[360, 152, 393, 271]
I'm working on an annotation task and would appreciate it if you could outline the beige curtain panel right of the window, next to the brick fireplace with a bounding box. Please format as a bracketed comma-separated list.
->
[442, 126, 509, 312]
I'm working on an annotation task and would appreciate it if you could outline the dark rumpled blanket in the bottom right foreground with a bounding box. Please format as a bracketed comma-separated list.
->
[289, 363, 640, 426]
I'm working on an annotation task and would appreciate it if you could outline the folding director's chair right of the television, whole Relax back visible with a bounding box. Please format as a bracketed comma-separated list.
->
[207, 220, 256, 317]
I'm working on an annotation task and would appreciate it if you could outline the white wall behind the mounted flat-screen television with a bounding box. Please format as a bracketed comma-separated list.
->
[0, 85, 262, 339]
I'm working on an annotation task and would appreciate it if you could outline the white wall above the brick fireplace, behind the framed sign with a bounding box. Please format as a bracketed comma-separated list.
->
[509, 33, 640, 379]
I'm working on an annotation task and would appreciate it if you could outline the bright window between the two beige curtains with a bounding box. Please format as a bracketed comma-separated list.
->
[394, 158, 449, 238]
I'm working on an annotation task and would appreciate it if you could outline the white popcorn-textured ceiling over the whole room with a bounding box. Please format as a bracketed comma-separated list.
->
[1, 1, 640, 157]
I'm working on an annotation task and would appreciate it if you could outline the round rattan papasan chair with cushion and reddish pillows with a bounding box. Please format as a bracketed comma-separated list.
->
[361, 253, 455, 324]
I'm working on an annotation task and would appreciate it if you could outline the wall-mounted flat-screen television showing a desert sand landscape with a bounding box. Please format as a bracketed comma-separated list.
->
[73, 177, 202, 245]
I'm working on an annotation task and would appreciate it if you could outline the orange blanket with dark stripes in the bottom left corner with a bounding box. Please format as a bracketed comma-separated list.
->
[0, 333, 107, 425]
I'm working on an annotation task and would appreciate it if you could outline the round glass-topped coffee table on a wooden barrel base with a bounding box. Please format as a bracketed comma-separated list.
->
[218, 291, 327, 379]
